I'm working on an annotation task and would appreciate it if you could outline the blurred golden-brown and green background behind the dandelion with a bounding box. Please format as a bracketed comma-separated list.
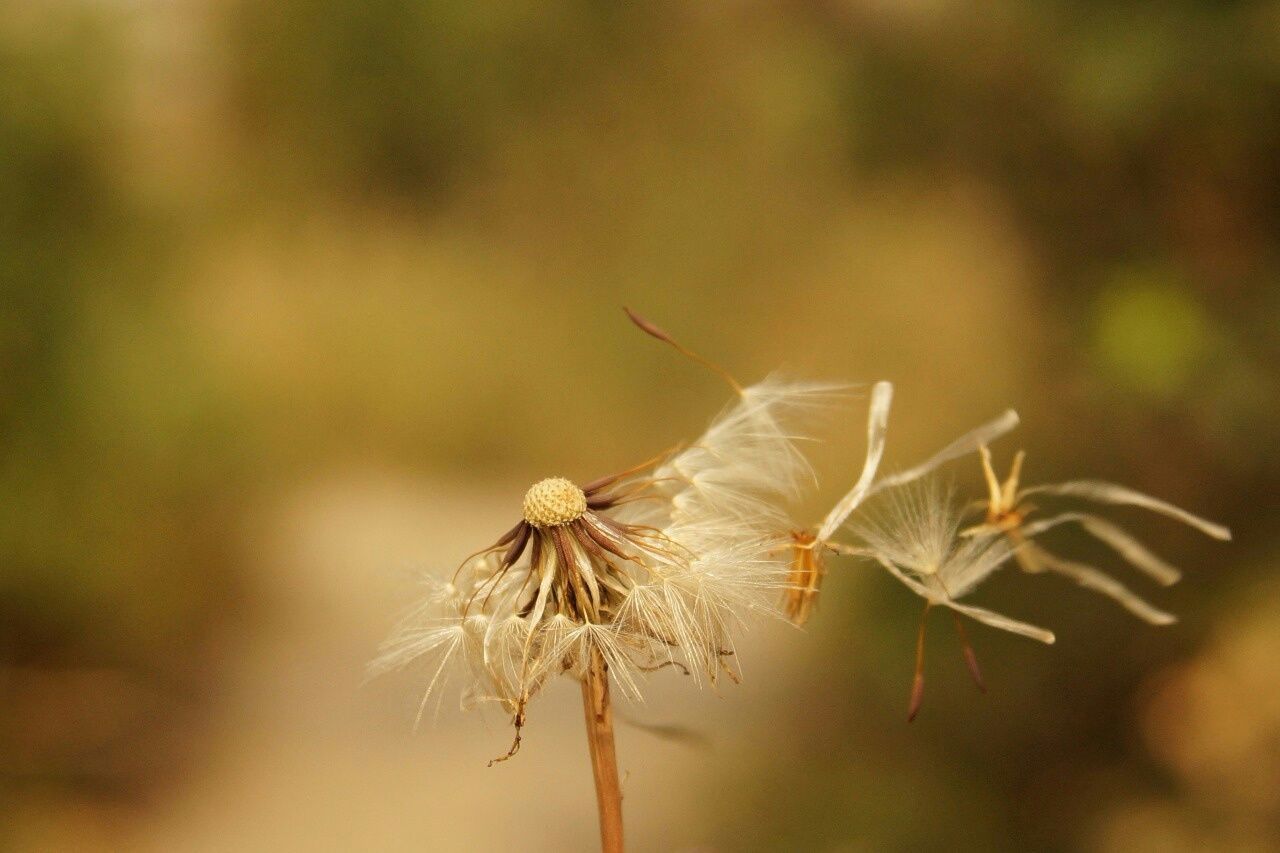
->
[0, 0, 1280, 850]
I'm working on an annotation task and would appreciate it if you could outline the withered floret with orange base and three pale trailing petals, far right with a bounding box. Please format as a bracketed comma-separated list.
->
[964, 446, 1231, 625]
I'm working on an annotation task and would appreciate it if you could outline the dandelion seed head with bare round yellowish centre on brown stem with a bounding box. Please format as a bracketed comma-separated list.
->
[370, 313, 831, 850]
